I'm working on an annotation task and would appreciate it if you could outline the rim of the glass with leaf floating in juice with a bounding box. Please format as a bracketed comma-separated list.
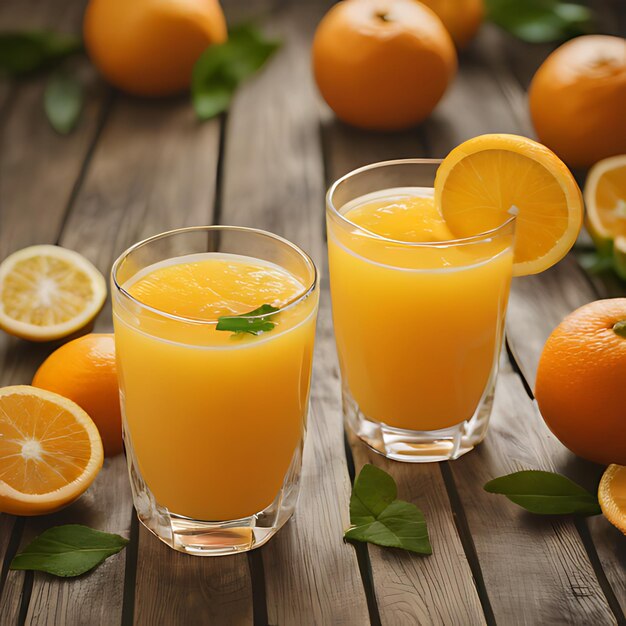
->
[111, 224, 319, 326]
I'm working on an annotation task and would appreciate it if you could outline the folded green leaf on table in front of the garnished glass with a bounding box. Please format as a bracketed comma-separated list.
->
[344, 465, 432, 554]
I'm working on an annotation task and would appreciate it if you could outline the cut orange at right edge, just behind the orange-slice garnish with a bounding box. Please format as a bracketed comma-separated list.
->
[584, 154, 626, 252]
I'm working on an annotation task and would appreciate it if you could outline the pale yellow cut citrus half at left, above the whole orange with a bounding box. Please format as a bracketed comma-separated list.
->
[0, 245, 107, 341]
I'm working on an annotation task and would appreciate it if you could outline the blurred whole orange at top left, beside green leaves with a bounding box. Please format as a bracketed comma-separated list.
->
[83, 0, 227, 96]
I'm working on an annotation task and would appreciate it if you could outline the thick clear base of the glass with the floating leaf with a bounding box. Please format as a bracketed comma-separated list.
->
[125, 428, 302, 556]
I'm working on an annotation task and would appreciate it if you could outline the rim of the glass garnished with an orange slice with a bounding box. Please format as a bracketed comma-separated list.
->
[326, 158, 517, 248]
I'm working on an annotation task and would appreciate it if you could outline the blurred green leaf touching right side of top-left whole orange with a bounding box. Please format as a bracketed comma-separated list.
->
[191, 24, 281, 120]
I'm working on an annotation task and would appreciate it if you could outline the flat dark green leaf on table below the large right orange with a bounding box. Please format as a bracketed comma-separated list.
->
[484, 470, 601, 515]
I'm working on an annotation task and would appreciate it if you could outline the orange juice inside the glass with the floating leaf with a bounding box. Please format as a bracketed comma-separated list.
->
[114, 253, 317, 520]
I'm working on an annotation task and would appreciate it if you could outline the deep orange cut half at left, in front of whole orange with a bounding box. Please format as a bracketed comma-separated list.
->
[0, 385, 103, 515]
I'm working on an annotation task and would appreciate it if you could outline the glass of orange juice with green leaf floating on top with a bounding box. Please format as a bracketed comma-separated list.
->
[112, 226, 318, 555]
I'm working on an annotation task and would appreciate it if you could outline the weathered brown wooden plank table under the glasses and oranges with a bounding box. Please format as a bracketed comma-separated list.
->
[0, 0, 626, 626]
